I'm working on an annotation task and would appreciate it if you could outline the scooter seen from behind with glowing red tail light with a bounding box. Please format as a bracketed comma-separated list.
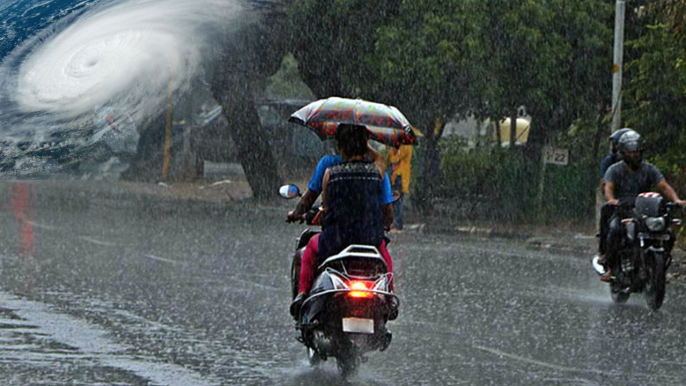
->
[280, 185, 400, 378]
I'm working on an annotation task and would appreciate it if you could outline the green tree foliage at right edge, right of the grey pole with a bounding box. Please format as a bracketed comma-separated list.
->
[622, 1, 686, 194]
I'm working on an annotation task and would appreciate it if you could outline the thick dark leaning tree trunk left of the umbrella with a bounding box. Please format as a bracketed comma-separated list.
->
[210, 11, 287, 201]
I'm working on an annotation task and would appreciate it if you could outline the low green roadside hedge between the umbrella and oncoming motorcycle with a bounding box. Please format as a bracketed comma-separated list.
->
[438, 143, 597, 221]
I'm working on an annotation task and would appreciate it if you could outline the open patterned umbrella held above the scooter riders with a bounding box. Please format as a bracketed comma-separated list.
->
[288, 97, 417, 147]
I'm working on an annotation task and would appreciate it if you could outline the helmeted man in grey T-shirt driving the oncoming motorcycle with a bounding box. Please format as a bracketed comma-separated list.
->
[600, 130, 686, 282]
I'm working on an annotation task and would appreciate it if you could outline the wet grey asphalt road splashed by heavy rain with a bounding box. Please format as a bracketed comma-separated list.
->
[0, 182, 686, 386]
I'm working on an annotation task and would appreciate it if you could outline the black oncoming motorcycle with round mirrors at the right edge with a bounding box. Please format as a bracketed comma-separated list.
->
[593, 193, 681, 310]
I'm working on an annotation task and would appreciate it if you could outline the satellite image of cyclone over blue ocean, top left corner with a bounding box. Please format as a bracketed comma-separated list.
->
[0, 0, 235, 178]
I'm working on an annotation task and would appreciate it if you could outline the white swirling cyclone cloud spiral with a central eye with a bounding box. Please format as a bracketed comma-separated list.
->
[0, 0, 241, 149]
